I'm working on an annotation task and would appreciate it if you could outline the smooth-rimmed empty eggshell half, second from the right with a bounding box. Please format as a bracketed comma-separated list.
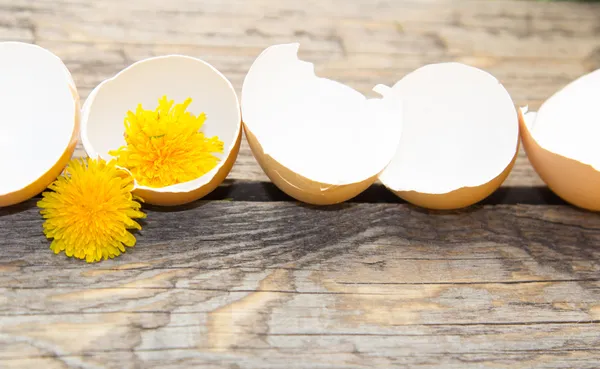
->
[377, 63, 519, 209]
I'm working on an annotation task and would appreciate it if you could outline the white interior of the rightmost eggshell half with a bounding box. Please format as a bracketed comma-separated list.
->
[530, 69, 600, 170]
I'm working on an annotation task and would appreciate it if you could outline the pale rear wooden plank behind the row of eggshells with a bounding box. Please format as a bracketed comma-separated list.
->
[0, 0, 600, 186]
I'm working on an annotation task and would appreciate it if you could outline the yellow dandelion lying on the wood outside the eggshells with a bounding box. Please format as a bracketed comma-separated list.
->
[38, 159, 146, 263]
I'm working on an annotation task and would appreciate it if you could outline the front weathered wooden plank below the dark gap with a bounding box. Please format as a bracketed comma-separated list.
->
[0, 201, 600, 368]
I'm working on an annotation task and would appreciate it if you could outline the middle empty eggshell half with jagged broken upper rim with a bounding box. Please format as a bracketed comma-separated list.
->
[241, 43, 402, 205]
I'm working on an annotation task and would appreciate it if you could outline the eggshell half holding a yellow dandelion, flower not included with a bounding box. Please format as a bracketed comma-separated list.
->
[81, 55, 242, 205]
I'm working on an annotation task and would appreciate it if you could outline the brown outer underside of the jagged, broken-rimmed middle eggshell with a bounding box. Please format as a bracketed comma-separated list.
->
[244, 124, 377, 205]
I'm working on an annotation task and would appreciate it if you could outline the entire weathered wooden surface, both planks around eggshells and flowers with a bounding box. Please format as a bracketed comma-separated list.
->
[0, 0, 600, 369]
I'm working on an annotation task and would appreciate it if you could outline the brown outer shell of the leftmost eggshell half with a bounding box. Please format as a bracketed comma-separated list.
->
[0, 85, 81, 207]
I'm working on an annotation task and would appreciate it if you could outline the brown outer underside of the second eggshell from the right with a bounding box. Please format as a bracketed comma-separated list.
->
[392, 145, 519, 210]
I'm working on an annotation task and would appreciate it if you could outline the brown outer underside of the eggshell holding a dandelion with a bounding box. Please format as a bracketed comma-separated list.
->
[133, 129, 242, 206]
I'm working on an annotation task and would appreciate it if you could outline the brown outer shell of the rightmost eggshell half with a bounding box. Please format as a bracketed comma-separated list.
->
[519, 110, 600, 211]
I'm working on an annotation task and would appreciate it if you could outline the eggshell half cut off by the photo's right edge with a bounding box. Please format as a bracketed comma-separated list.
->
[521, 70, 600, 211]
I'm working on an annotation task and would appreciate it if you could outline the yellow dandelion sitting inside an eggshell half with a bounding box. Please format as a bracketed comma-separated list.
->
[109, 96, 223, 187]
